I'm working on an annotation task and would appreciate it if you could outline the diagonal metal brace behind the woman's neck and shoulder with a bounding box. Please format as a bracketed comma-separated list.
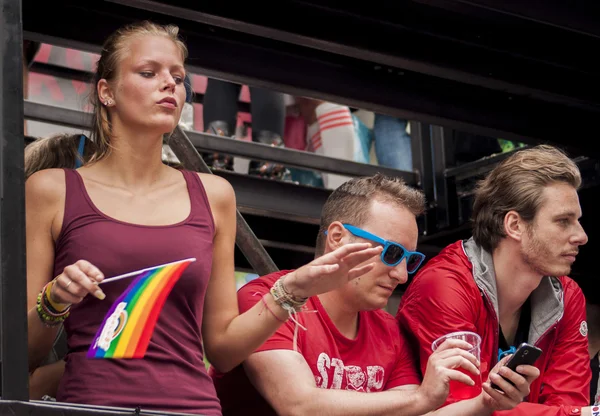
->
[169, 126, 279, 275]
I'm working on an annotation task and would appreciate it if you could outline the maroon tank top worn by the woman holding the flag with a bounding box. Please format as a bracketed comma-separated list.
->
[54, 169, 221, 415]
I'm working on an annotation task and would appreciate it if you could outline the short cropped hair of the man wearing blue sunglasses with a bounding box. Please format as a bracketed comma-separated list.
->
[316, 173, 425, 256]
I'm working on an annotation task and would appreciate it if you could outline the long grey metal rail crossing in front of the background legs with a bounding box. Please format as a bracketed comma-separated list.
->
[25, 101, 417, 185]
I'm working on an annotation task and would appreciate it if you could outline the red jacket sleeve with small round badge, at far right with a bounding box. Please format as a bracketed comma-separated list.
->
[494, 280, 592, 416]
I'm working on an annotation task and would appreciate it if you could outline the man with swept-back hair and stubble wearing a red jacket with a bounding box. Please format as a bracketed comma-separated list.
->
[396, 146, 600, 416]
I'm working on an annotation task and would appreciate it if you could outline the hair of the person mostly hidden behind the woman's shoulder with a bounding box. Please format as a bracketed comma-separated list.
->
[25, 134, 96, 180]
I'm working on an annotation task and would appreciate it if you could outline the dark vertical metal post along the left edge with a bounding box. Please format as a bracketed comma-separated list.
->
[0, 0, 29, 400]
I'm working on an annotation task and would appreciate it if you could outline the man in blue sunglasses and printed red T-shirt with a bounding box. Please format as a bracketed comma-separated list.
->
[211, 175, 536, 416]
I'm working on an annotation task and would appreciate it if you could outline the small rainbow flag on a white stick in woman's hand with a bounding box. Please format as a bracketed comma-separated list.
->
[87, 258, 196, 358]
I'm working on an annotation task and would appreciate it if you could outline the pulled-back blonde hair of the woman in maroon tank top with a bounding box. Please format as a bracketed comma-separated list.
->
[90, 21, 188, 161]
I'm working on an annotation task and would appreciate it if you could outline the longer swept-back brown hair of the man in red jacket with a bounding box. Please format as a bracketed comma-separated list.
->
[472, 145, 581, 252]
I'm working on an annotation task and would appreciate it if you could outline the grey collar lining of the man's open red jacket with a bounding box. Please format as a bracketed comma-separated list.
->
[462, 237, 564, 344]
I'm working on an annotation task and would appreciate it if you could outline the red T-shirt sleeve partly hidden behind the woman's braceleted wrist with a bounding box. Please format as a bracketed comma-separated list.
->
[238, 273, 301, 353]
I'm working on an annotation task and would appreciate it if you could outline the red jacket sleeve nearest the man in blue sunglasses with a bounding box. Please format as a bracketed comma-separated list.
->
[396, 266, 480, 386]
